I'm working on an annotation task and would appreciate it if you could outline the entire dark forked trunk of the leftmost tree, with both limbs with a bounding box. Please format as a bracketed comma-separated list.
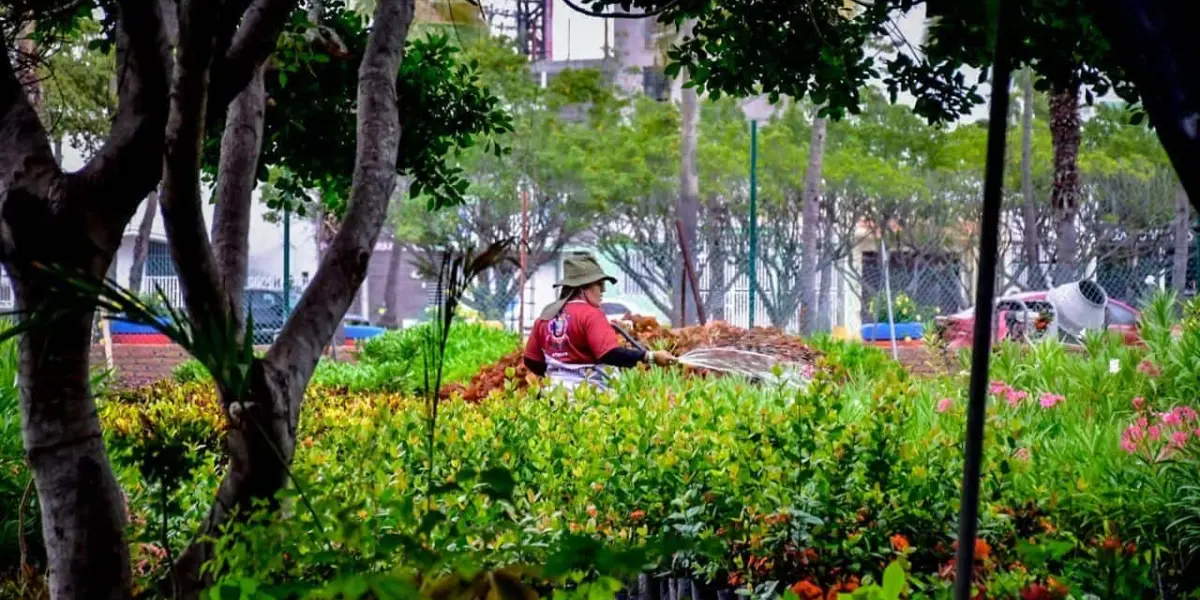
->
[0, 1, 168, 599]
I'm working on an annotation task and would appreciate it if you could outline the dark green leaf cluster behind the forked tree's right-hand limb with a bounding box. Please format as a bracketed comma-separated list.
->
[205, 1, 511, 214]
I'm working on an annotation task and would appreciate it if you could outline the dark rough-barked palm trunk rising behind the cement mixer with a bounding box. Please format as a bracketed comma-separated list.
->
[1050, 85, 1081, 286]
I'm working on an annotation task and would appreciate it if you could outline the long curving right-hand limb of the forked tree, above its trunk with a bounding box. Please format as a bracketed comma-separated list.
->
[266, 0, 413, 393]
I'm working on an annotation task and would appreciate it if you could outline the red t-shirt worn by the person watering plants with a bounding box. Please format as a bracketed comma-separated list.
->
[524, 300, 620, 365]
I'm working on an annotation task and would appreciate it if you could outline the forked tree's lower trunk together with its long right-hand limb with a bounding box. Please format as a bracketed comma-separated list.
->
[175, 0, 413, 598]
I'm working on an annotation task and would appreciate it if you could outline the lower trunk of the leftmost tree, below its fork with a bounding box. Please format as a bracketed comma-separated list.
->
[11, 286, 132, 599]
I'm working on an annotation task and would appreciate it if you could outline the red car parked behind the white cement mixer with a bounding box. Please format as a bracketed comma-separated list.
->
[936, 292, 1141, 348]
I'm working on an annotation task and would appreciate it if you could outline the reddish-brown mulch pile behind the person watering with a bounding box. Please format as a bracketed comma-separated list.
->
[440, 316, 821, 402]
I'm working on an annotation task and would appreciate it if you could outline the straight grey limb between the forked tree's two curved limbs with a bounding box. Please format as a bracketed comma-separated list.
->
[212, 66, 266, 322]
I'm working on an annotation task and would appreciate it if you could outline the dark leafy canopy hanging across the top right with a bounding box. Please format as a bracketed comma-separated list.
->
[578, 0, 1138, 122]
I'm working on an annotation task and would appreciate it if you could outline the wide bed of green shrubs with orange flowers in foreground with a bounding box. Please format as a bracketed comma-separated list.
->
[102, 334, 1200, 598]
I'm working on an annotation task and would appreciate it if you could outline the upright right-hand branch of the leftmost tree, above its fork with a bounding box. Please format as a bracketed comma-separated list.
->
[71, 0, 170, 218]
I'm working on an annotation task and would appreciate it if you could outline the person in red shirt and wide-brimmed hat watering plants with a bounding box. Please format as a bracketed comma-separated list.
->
[524, 252, 676, 390]
